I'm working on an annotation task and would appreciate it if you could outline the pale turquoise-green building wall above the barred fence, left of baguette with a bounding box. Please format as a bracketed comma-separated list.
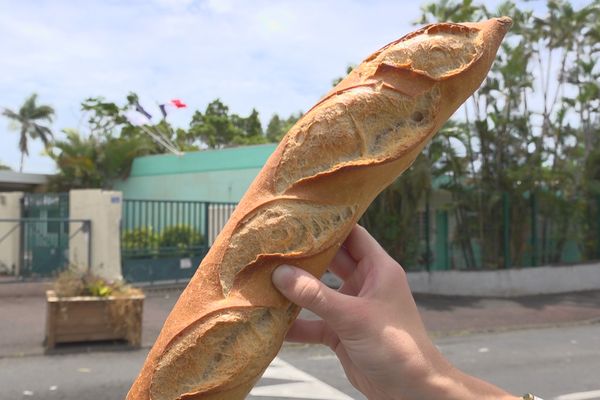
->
[115, 144, 276, 202]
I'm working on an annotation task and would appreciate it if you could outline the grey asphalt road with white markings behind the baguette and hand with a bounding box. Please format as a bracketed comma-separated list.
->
[0, 324, 600, 400]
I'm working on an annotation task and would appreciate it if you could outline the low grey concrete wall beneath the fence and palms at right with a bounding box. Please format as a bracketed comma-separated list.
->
[408, 263, 600, 297]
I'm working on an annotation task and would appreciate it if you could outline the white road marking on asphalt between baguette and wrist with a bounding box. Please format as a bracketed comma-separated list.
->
[250, 358, 354, 400]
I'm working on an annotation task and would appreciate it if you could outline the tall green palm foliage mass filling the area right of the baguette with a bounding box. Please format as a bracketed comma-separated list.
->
[363, 0, 600, 268]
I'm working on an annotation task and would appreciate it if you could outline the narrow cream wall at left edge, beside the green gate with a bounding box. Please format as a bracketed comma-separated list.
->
[0, 192, 23, 275]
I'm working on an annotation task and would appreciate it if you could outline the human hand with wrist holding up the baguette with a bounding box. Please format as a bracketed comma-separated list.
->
[273, 225, 516, 400]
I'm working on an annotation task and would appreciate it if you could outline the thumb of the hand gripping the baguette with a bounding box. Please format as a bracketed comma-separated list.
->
[273, 265, 345, 320]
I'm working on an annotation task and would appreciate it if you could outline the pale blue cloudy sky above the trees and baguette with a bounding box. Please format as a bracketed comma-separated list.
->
[0, 0, 576, 172]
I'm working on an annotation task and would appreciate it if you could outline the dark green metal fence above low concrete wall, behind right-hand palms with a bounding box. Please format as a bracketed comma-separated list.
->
[390, 193, 600, 270]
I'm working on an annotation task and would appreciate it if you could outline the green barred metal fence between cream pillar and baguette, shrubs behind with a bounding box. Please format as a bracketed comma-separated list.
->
[121, 199, 236, 283]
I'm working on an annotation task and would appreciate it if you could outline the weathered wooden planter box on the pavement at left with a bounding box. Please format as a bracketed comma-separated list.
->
[46, 290, 145, 350]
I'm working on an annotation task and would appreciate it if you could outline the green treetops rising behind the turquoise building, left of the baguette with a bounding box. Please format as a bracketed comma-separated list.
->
[48, 93, 299, 191]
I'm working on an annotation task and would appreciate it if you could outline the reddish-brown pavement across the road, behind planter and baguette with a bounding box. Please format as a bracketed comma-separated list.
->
[0, 282, 600, 358]
